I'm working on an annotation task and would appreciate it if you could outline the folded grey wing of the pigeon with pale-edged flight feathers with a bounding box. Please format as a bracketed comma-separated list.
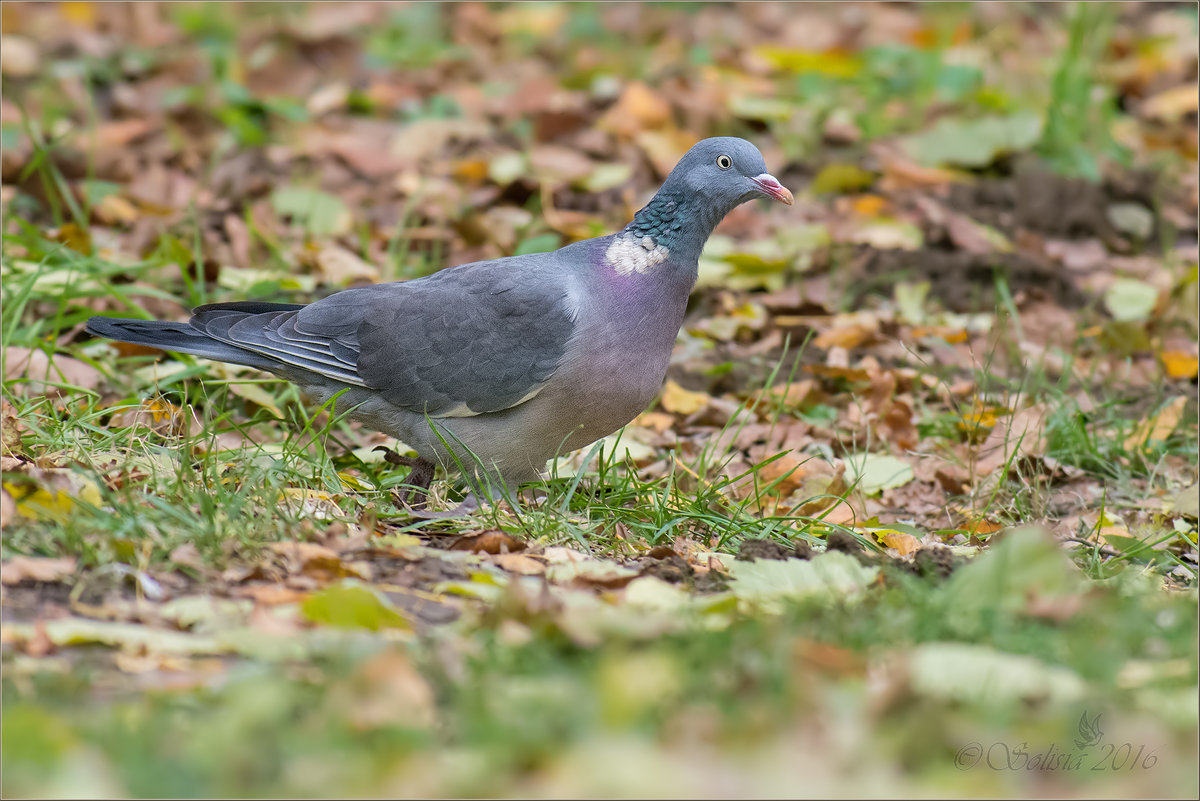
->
[192, 257, 575, 417]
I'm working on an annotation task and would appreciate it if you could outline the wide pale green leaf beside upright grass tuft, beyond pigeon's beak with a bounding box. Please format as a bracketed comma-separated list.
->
[900, 112, 1042, 167]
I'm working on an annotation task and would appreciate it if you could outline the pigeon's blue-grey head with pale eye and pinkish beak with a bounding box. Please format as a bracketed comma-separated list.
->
[662, 137, 792, 212]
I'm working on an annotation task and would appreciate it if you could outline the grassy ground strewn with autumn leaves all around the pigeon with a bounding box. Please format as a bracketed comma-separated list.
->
[0, 2, 1200, 797]
